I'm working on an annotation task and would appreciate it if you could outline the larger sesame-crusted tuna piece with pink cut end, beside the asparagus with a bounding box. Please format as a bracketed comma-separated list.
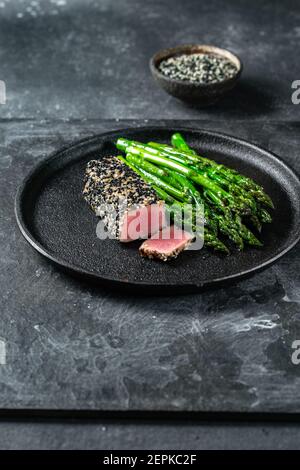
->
[83, 156, 166, 242]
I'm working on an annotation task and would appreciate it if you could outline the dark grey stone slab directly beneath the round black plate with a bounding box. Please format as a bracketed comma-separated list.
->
[0, 121, 300, 412]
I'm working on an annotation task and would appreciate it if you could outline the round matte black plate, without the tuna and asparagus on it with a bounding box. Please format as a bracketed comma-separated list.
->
[15, 127, 300, 294]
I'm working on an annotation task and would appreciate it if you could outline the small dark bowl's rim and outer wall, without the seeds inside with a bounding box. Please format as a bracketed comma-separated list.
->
[150, 44, 243, 106]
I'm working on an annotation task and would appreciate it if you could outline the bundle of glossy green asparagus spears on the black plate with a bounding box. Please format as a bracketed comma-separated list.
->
[116, 133, 273, 253]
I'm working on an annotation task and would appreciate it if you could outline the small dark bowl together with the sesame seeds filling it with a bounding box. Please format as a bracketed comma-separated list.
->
[150, 45, 242, 106]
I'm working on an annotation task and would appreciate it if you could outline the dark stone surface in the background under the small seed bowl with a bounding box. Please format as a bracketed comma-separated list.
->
[0, 0, 300, 120]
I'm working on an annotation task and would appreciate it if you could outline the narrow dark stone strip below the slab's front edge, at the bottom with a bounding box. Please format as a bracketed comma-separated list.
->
[0, 420, 300, 450]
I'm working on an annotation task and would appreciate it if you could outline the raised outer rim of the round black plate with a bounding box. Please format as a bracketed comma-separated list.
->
[14, 125, 300, 295]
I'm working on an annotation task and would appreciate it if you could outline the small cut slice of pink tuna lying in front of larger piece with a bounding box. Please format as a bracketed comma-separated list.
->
[139, 225, 195, 261]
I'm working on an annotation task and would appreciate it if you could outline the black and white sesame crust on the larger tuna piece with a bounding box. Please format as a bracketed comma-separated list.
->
[83, 156, 158, 238]
